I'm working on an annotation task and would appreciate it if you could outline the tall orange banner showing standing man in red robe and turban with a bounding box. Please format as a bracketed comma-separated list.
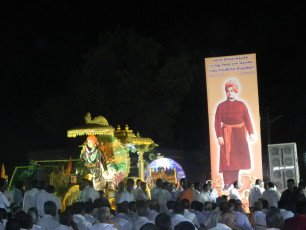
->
[205, 54, 262, 207]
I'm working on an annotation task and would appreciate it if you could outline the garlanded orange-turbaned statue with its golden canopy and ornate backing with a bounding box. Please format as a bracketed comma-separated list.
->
[67, 113, 130, 190]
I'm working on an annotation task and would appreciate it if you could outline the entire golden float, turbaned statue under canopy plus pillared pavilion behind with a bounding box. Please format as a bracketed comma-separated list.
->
[67, 113, 157, 189]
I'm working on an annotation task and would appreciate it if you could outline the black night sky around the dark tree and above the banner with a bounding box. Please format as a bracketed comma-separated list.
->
[0, 0, 306, 180]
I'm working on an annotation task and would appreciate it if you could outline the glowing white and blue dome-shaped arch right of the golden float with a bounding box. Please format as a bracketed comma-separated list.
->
[146, 157, 186, 180]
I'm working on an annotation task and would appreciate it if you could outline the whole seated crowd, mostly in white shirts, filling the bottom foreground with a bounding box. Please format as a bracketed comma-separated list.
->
[0, 175, 306, 230]
